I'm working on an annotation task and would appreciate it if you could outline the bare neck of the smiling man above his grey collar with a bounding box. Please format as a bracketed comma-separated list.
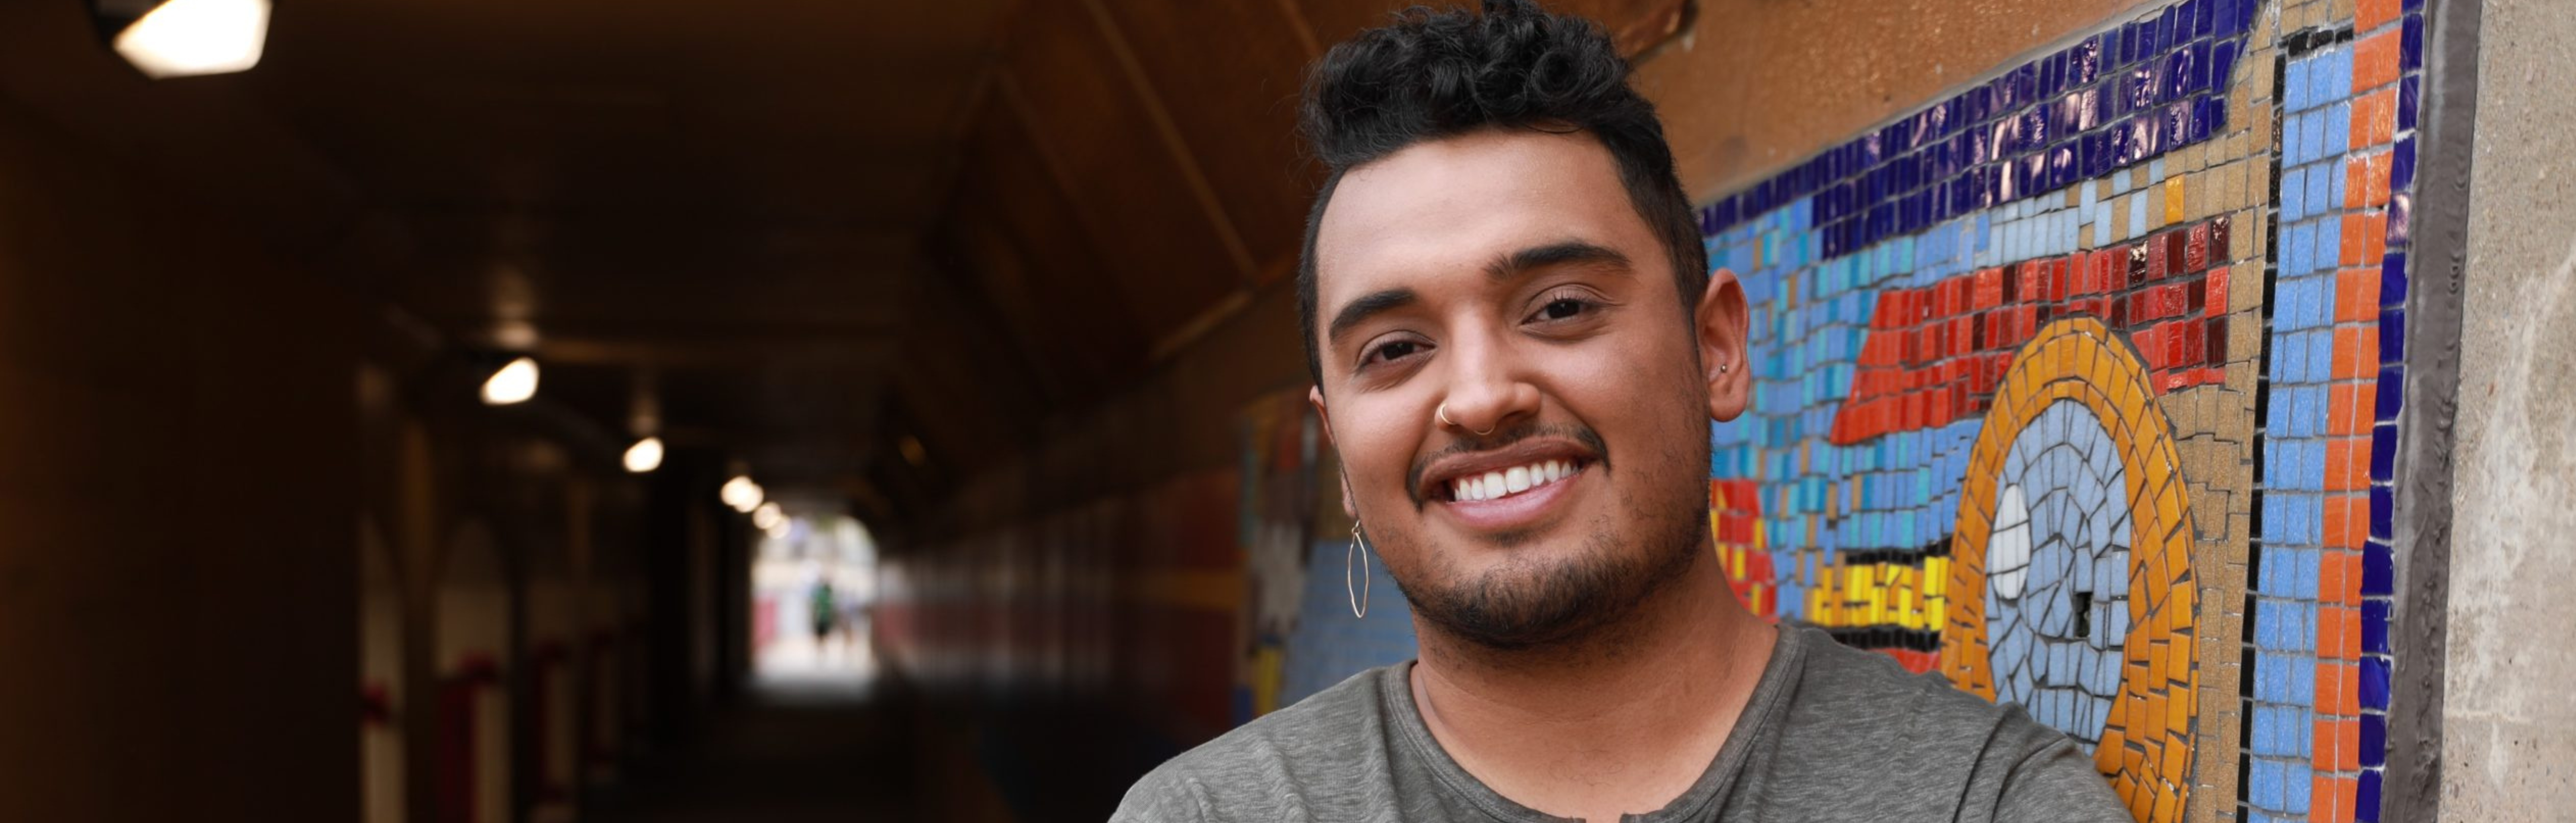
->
[1412, 544, 1775, 820]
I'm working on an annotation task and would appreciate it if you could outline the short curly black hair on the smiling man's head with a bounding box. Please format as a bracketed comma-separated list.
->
[1296, 0, 1708, 384]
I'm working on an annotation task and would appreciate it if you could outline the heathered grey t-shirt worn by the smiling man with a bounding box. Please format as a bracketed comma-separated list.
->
[1110, 627, 2128, 823]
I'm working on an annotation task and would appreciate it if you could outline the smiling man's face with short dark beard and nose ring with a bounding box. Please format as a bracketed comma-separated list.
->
[1314, 129, 1742, 647]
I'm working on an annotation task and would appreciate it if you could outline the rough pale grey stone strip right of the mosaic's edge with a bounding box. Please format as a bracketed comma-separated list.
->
[2440, 0, 2576, 820]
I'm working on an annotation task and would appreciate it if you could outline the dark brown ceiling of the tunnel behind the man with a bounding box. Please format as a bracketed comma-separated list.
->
[0, 0, 1685, 526]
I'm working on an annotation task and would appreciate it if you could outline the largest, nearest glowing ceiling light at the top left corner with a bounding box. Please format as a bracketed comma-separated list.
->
[90, 0, 268, 80]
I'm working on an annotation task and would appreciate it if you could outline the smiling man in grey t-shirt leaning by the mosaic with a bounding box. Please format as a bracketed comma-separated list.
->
[1118, 0, 2125, 820]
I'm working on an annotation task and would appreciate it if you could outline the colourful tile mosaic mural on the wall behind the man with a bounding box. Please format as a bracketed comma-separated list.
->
[1700, 0, 2424, 820]
